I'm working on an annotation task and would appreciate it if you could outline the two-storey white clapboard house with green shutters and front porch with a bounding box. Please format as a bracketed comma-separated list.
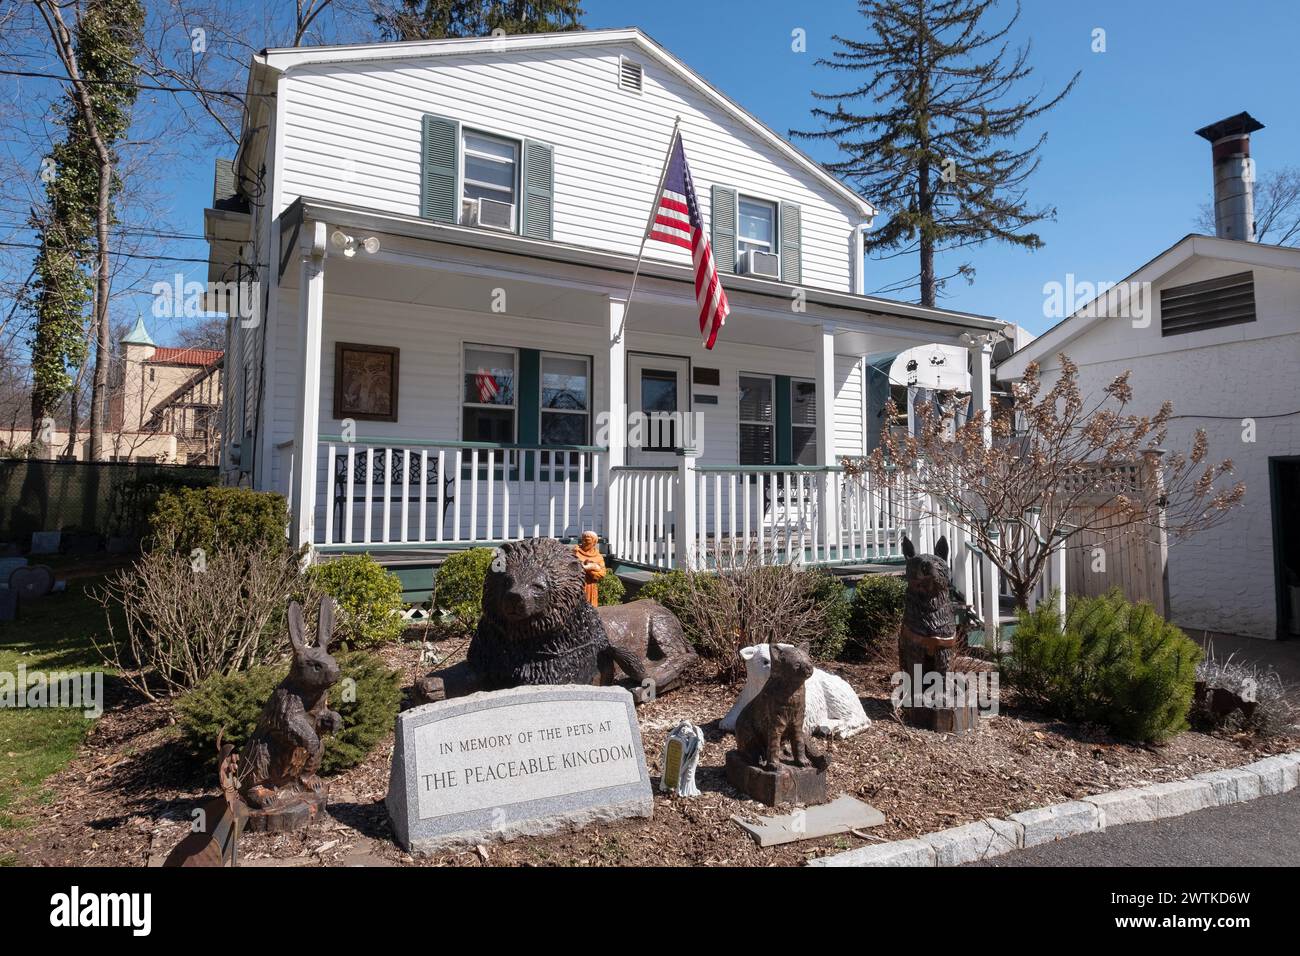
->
[207, 29, 1024, 621]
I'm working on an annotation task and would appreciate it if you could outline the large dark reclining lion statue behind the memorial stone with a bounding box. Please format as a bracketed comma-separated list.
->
[416, 538, 696, 704]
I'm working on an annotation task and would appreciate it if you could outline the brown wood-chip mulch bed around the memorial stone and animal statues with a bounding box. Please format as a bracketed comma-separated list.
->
[0, 644, 1300, 866]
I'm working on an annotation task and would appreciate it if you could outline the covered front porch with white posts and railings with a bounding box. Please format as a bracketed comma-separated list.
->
[271, 206, 1055, 629]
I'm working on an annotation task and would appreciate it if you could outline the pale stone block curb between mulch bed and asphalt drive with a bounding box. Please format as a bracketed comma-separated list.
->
[809, 750, 1300, 866]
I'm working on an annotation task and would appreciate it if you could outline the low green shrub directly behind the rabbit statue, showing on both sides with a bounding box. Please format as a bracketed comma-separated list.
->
[176, 652, 402, 774]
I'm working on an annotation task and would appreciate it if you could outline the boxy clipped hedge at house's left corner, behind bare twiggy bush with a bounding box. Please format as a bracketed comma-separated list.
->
[147, 485, 289, 554]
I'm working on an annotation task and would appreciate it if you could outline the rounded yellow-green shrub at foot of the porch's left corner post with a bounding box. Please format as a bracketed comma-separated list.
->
[307, 554, 404, 646]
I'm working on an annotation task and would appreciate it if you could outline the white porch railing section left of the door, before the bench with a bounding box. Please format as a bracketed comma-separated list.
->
[315, 436, 605, 548]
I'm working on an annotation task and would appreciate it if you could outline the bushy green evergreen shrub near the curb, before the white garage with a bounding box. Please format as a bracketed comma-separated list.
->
[1008, 589, 1201, 744]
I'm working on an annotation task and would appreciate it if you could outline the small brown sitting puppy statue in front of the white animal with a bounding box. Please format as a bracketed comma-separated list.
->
[736, 644, 820, 770]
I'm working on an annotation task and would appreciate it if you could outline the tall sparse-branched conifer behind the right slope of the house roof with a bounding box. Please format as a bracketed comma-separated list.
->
[794, 0, 1079, 306]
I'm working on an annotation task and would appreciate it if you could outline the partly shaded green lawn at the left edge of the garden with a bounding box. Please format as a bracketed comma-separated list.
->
[0, 578, 105, 832]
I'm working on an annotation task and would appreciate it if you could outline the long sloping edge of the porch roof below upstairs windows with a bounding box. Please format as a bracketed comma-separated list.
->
[280, 196, 1006, 337]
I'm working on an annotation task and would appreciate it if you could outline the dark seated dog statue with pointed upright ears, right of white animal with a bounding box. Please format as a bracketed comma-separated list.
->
[898, 536, 957, 676]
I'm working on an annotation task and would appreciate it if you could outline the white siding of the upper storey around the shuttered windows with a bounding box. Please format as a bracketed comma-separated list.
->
[277, 43, 859, 291]
